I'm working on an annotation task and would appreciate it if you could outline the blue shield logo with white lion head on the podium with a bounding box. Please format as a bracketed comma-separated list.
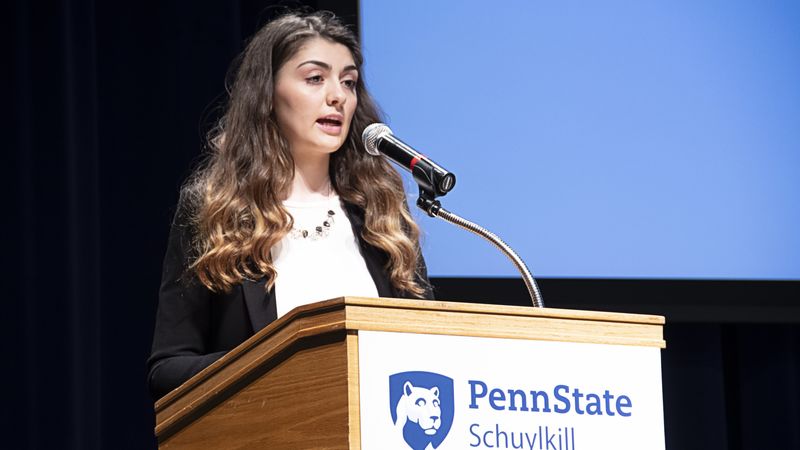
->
[389, 372, 454, 450]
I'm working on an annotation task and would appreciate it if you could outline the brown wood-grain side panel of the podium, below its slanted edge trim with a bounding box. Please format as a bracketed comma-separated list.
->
[159, 340, 350, 450]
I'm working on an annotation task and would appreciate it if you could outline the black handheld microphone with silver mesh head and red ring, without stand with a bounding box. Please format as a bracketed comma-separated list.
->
[361, 123, 456, 197]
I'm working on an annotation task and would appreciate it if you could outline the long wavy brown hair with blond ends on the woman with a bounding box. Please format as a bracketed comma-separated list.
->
[183, 12, 425, 296]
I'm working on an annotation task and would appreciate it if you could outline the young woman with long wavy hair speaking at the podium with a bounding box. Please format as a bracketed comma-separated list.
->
[148, 13, 431, 398]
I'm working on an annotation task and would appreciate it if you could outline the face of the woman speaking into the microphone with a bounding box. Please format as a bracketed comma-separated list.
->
[274, 38, 358, 159]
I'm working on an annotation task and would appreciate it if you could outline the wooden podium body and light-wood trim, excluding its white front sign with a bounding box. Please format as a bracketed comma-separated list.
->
[155, 297, 665, 449]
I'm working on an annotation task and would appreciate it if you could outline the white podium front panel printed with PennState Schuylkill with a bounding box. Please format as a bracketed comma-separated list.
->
[358, 330, 664, 450]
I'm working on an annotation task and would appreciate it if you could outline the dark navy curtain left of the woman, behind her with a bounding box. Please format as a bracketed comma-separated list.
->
[6, 0, 357, 449]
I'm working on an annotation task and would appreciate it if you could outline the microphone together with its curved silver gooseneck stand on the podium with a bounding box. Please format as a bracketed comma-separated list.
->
[361, 123, 544, 308]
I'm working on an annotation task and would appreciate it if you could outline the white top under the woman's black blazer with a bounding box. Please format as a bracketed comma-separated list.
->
[270, 196, 378, 317]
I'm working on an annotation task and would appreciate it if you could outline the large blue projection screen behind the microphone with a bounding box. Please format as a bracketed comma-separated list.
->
[360, 0, 800, 280]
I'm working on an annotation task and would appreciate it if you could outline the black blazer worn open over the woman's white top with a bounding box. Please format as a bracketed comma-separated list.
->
[147, 196, 433, 399]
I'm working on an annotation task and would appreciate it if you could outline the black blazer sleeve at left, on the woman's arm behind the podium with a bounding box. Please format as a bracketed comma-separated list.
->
[147, 195, 226, 399]
